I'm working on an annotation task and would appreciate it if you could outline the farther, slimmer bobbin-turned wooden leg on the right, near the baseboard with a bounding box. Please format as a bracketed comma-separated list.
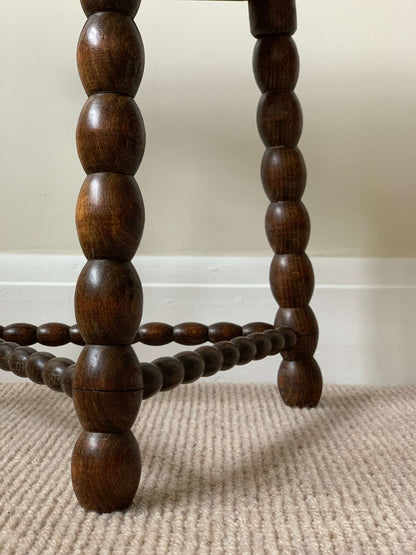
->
[249, 0, 322, 407]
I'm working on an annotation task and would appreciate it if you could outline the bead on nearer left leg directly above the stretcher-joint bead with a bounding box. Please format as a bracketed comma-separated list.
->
[75, 260, 143, 345]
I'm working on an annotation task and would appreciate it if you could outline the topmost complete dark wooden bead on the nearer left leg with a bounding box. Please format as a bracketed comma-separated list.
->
[77, 12, 144, 97]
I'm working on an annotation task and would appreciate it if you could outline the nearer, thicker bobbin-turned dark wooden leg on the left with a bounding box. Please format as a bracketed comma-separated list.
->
[72, 0, 145, 512]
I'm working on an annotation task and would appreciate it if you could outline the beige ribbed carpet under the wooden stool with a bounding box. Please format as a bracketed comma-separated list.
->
[0, 382, 416, 555]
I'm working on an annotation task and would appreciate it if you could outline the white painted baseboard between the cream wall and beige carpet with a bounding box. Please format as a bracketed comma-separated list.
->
[0, 254, 416, 385]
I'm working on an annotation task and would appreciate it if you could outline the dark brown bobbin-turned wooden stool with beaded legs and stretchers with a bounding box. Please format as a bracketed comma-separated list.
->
[0, 0, 322, 512]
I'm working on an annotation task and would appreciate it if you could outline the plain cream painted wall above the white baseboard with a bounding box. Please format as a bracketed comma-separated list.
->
[0, 0, 416, 257]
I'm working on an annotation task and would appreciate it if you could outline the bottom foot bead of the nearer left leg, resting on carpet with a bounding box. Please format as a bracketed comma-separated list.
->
[71, 431, 141, 513]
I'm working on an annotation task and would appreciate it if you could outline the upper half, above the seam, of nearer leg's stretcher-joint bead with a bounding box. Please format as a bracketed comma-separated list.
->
[73, 345, 143, 391]
